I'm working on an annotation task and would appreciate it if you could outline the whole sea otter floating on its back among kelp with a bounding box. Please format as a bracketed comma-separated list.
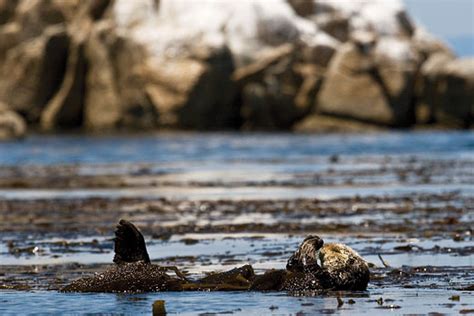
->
[62, 220, 369, 292]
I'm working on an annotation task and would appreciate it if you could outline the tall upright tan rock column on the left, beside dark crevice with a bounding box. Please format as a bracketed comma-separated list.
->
[84, 21, 157, 130]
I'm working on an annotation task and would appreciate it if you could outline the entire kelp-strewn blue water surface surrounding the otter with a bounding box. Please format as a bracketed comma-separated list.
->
[0, 132, 474, 315]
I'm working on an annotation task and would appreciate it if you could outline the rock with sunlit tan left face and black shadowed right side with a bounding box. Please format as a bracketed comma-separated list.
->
[146, 47, 240, 130]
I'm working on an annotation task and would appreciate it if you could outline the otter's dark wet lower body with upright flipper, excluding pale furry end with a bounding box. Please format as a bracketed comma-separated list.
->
[61, 219, 255, 292]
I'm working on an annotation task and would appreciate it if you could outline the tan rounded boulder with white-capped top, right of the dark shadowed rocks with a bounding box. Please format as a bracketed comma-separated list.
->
[317, 38, 418, 126]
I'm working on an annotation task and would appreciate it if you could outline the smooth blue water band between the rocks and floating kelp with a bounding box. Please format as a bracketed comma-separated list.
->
[0, 132, 474, 165]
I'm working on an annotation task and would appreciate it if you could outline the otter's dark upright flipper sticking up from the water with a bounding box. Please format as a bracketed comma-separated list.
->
[114, 219, 150, 264]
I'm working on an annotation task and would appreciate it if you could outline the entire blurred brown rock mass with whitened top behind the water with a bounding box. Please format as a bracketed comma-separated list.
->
[0, 0, 474, 139]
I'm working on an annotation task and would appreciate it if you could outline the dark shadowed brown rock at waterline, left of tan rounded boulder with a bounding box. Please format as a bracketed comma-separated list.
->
[239, 45, 334, 129]
